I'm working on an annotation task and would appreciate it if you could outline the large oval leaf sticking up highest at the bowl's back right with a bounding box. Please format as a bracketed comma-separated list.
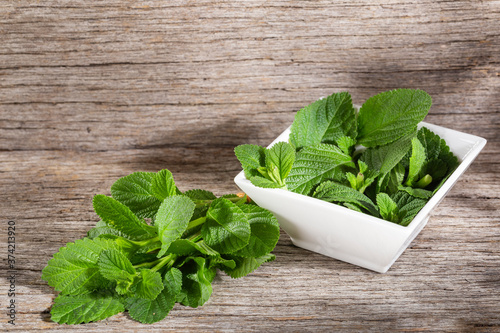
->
[357, 89, 432, 147]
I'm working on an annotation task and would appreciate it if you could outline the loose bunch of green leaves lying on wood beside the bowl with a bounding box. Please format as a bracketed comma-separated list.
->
[42, 170, 280, 324]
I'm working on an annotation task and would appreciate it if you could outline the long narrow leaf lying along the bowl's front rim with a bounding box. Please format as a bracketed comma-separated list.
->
[312, 181, 378, 216]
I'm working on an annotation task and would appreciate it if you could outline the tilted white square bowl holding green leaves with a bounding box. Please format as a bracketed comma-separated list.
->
[234, 122, 486, 273]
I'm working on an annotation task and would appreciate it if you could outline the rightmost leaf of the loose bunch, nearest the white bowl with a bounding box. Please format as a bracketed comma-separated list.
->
[234, 205, 280, 257]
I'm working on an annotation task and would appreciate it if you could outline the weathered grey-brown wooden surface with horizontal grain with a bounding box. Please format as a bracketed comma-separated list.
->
[0, 0, 500, 332]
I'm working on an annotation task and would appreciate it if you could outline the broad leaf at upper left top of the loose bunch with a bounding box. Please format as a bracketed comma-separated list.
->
[111, 172, 161, 218]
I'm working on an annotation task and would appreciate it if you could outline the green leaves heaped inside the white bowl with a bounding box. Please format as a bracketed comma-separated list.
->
[235, 89, 458, 226]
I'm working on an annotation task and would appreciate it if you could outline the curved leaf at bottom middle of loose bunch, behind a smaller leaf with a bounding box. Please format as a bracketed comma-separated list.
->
[126, 268, 182, 324]
